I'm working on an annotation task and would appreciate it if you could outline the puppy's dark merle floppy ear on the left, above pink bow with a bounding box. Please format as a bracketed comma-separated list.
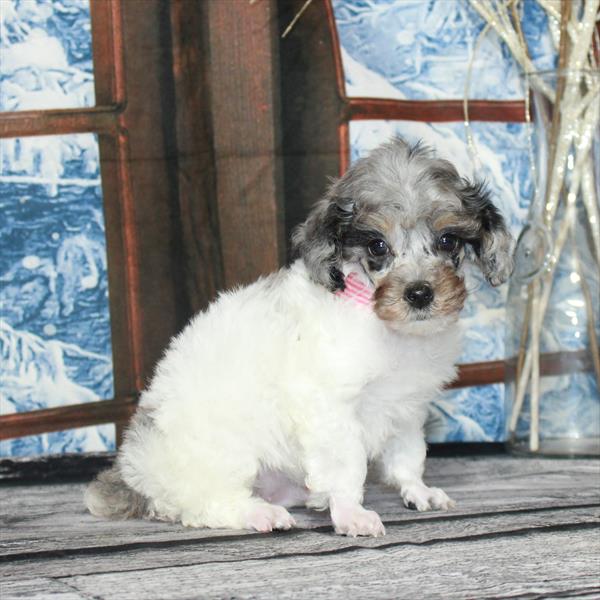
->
[292, 194, 354, 291]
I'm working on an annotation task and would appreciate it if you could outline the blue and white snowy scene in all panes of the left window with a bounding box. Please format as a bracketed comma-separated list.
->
[0, 0, 114, 456]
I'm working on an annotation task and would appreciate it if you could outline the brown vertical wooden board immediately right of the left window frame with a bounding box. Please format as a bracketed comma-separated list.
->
[118, 0, 195, 380]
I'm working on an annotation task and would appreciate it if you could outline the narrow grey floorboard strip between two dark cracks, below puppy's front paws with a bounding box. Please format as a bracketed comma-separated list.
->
[0, 504, 600, 580]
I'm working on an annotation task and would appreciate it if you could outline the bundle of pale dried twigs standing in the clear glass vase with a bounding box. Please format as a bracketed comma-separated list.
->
[466, 0, 600, 451]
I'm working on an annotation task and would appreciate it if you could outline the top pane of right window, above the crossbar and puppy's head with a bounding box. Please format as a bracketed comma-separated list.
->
[332, 0, 556, 100]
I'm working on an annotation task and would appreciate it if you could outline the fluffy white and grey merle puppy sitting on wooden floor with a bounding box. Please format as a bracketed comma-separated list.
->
[86, 139, 513, 536]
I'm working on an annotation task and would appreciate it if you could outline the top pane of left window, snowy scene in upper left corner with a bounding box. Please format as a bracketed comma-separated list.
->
[0, 0, 95, 111]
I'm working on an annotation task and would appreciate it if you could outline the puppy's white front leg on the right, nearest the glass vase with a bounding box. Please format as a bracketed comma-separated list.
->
[381, 424, 455, 511]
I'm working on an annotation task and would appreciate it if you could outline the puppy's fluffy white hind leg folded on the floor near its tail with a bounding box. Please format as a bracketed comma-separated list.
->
[120, 425, 295, 532]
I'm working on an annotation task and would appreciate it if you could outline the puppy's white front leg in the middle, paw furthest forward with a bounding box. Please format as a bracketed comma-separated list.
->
[301, 414, 385, 537]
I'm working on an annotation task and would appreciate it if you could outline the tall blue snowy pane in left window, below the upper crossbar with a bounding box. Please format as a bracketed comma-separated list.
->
[0, 134, 114, 454]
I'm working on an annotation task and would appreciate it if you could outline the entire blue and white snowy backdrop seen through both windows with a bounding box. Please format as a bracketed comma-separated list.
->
[0, 0, 555, 456]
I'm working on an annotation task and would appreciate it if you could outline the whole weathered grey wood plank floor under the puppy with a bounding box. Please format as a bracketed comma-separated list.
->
[0, 456, 600, 600]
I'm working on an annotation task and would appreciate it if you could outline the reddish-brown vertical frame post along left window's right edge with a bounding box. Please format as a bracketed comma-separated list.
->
[90, 0, 144, 408]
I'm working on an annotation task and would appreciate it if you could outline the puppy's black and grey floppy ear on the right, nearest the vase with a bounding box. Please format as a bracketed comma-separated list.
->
[458, 179, 515, 286]
